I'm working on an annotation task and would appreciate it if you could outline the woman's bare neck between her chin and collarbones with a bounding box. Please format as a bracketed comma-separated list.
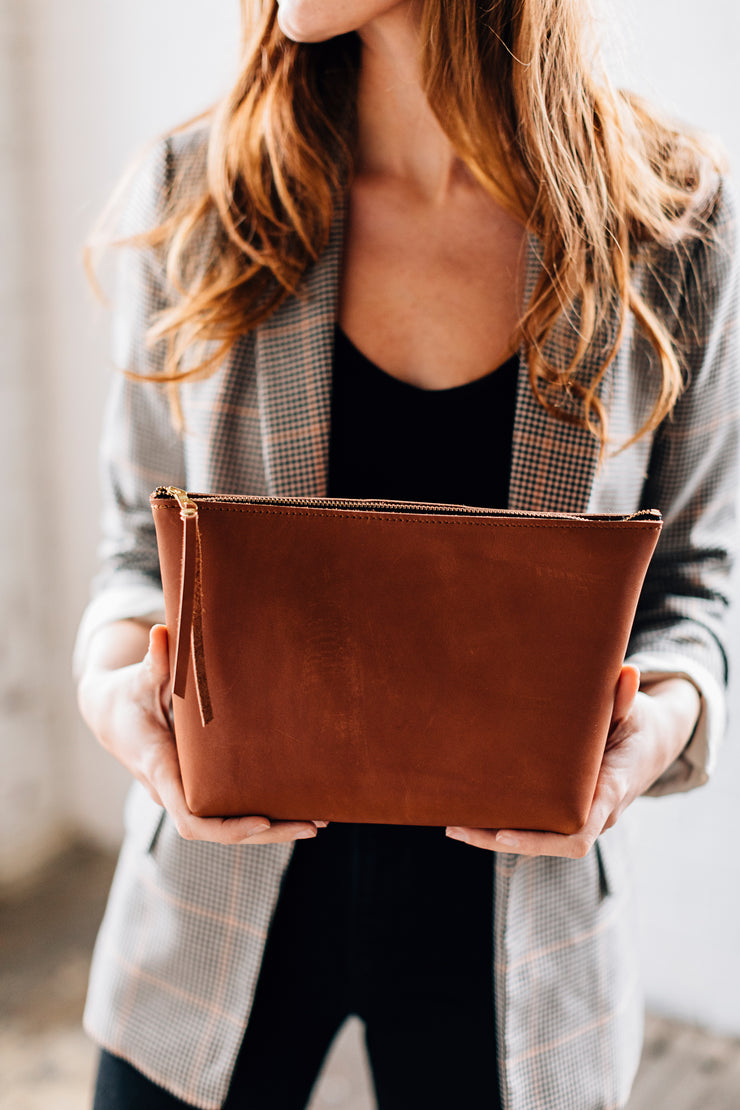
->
[357, 4, 468, 203]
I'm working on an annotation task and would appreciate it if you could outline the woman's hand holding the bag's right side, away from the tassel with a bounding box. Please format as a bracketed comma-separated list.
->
[447, 664, 700, 859]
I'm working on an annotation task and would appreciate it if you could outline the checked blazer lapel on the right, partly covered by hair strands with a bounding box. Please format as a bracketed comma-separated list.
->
[509, 235, 605, 513]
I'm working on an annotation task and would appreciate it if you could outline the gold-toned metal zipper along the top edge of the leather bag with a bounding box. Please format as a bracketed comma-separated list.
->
[153, 486, 661, 522]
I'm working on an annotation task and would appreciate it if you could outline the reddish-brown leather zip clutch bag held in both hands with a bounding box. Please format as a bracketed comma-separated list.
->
[151, 487, 661, 833]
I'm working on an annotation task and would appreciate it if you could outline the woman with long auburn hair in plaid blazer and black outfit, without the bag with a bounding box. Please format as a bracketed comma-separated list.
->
[78, 0, 737, 1110]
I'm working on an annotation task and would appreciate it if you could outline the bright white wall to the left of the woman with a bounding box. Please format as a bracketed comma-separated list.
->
[21, 0, 239, 842]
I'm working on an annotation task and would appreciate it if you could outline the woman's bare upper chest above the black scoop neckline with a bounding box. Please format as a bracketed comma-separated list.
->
[338, 173, 525, 389]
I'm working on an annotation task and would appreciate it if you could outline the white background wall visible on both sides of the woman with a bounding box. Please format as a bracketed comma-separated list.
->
[5, 0, 740, 1033]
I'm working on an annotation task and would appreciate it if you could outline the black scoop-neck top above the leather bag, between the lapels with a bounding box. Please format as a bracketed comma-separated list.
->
[328, 326, 519, 508]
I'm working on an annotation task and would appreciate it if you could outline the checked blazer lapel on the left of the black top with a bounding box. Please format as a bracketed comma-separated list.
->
[255, 200, 346, 497]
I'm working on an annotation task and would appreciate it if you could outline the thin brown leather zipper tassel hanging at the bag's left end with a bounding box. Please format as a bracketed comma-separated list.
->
[168, 486, 213, 725]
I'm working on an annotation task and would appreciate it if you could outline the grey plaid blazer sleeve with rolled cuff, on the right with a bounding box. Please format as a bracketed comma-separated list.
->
[627, 177, 740, 795]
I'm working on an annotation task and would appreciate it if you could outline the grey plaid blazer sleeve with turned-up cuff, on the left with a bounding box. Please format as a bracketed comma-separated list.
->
[74, 140, 185, 674]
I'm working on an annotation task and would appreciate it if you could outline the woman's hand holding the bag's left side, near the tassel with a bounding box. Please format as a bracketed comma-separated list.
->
[79, 620, 326, 845]
